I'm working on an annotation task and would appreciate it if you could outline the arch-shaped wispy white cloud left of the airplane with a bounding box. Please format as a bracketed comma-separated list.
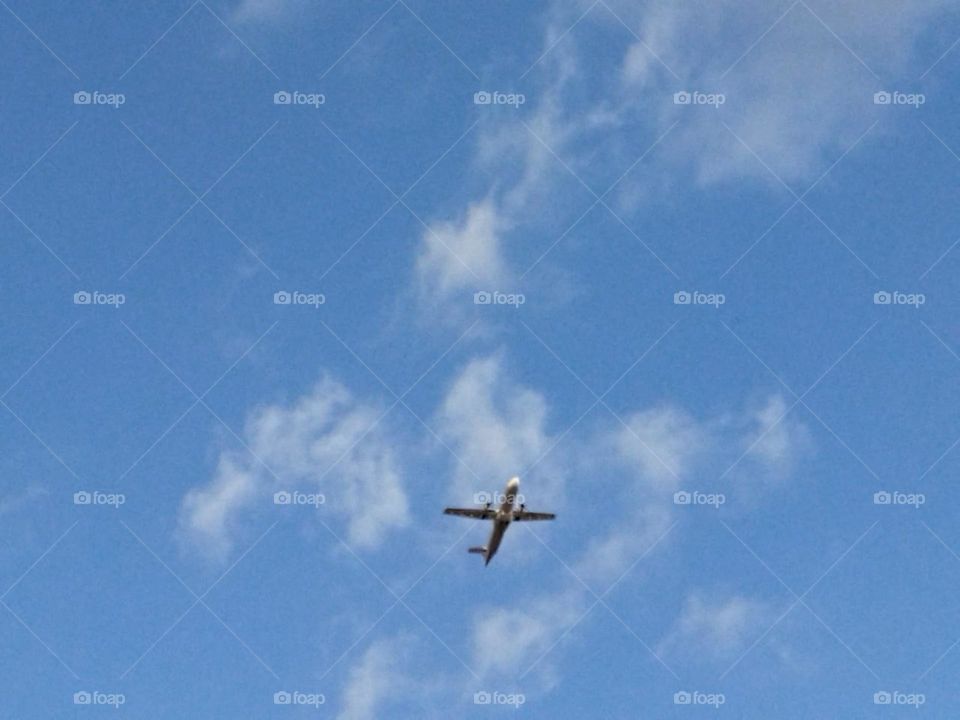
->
[180, 378, 409, 558]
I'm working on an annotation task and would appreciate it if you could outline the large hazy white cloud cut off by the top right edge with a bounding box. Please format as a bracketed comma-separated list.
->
[616, 0, 947, 186]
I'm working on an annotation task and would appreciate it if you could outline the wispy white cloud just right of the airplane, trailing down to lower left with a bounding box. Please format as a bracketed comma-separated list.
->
[572, 395, 813, 616]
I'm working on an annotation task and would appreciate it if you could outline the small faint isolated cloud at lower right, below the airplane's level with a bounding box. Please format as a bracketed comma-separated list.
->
[657, 593, 777, 660]
